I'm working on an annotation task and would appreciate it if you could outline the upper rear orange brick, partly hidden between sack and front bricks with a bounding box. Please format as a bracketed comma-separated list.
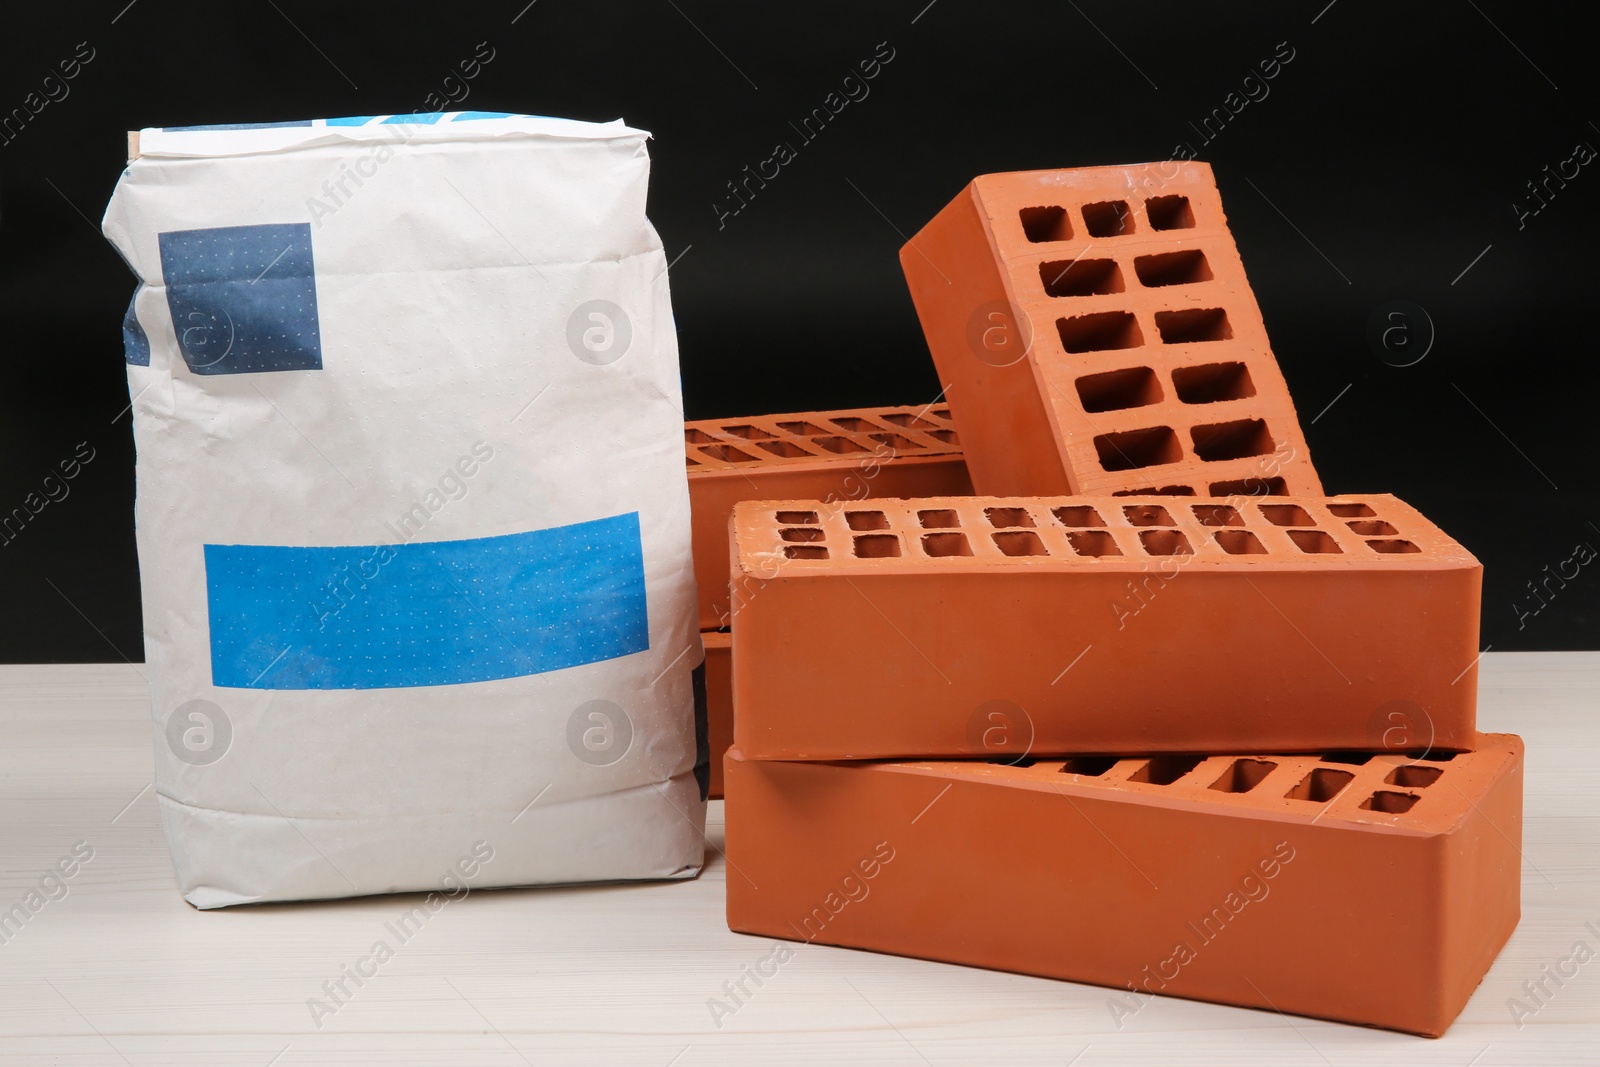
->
[683, 405, 973, 630]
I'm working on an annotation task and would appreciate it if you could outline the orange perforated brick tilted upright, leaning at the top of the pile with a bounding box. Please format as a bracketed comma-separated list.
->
[901, 162, 1322, 496]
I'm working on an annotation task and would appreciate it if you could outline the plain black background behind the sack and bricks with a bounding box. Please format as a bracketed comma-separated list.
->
[0, 0, 1600, 662]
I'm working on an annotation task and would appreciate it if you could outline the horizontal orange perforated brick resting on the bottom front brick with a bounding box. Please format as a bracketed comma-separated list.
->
[731, 496, 1482, 760]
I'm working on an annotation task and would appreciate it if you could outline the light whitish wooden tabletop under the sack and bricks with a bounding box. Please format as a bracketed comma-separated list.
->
[0, 653, 1600, 1067]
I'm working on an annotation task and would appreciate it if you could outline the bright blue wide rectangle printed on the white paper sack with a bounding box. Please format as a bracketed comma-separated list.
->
[205, 512, 650, 689]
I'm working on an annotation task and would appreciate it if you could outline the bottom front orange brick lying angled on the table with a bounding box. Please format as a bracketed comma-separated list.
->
[726, 734, 1523, 1035]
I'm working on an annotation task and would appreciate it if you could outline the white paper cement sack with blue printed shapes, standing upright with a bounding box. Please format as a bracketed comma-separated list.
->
[104, 112, 707, 907]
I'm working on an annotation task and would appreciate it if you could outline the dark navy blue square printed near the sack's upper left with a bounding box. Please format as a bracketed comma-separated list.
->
[160, 222, 322, 374]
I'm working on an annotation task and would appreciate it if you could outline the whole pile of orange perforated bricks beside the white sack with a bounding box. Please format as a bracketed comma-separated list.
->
[686, 163, 1522, 1035]
